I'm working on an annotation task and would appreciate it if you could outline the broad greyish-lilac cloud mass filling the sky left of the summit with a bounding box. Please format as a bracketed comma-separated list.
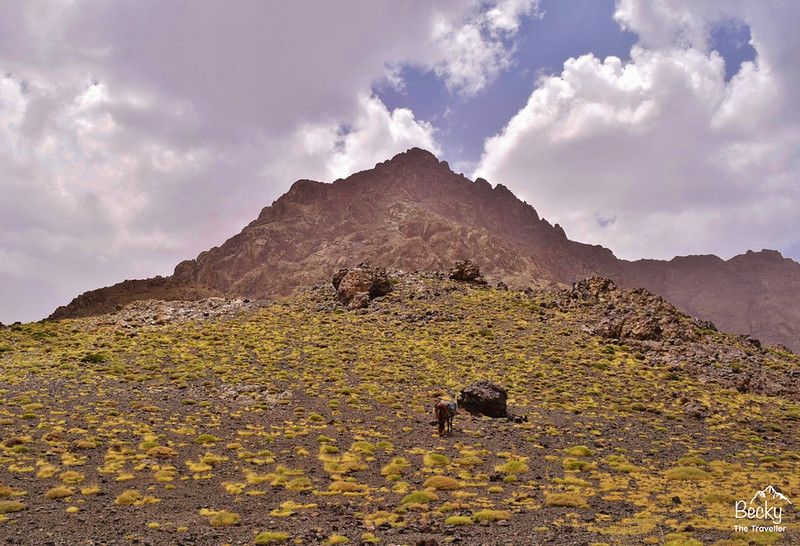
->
[0, 0, 535, 322]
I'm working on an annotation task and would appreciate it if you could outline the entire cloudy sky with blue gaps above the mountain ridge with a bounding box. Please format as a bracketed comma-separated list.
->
[0, 0, 800, 324]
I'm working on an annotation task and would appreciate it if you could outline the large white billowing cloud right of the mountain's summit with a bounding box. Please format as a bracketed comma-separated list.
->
[475, 0, 800, 259]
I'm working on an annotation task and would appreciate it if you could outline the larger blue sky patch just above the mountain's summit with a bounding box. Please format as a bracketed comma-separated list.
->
[373, 0, 637, 165]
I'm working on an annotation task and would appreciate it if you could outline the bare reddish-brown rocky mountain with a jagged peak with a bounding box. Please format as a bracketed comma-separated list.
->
[50, 148, 800, 350]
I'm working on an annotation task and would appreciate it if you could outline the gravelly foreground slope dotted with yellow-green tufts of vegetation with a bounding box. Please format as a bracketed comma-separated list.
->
[0, 274, 800, 544]
